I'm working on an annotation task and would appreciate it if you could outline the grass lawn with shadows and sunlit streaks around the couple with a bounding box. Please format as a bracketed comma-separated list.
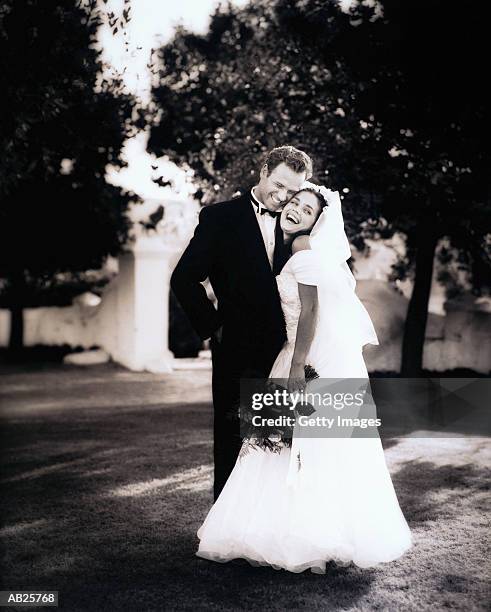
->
[0, 364, 490, 612]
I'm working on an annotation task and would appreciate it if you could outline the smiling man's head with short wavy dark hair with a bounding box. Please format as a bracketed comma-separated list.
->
[255, 146, 312, 210]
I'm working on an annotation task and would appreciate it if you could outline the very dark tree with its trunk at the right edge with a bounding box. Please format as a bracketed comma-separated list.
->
[311, 0, 491, 376]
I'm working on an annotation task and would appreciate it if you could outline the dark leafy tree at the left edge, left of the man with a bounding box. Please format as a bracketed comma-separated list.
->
[0, 0, 134, 350]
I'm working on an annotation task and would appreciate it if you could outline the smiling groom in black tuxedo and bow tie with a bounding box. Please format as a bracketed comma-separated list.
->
[171, 146, 312, 500]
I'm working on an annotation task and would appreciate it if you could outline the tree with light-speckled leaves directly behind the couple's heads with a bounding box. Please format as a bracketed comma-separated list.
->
[147, 0, 371, 244]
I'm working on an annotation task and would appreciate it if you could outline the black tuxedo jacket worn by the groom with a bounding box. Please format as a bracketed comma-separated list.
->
[171, 191, 288, 376]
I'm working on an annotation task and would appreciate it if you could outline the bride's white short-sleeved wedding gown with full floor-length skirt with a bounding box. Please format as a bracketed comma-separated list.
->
[196, 251, 411, 573]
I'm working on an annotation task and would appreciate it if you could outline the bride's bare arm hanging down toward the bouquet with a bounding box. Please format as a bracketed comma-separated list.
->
[288, 283, 318, 393]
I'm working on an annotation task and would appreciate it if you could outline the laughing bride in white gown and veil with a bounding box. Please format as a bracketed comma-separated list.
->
[196, 183, 411, 573]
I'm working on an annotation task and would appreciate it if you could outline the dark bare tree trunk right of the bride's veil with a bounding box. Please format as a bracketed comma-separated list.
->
[401, 218, 438, 377]
